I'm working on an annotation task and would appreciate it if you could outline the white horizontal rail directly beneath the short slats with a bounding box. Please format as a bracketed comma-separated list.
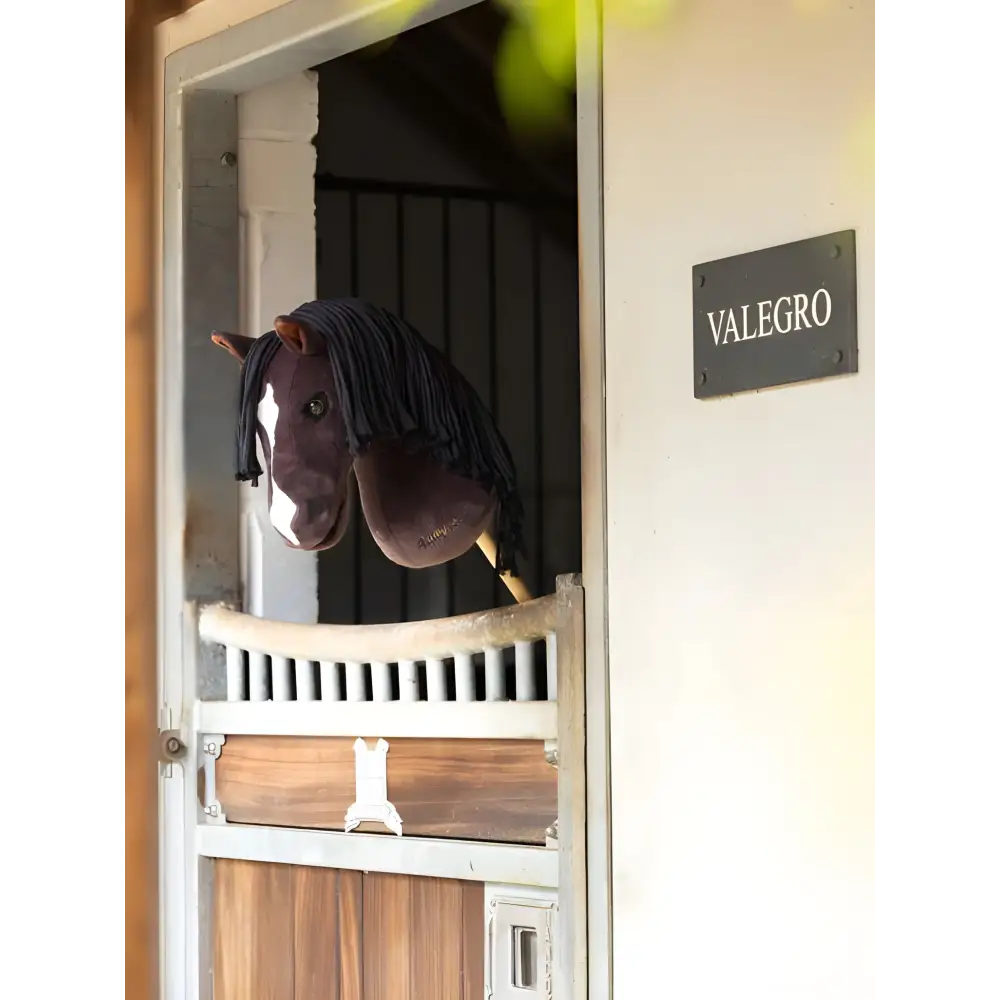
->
[195, 701, 558, 740]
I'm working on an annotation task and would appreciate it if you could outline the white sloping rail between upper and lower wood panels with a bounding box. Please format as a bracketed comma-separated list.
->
[196, 824, 559, 888]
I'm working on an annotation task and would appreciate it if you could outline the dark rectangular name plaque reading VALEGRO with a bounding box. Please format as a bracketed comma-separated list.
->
[692, 229, 858, 399]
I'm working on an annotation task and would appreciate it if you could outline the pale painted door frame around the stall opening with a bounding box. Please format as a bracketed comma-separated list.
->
[157, 0, 611, 1000]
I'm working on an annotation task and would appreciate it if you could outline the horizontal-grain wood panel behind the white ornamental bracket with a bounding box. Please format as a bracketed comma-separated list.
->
[216, 736, 557, 844]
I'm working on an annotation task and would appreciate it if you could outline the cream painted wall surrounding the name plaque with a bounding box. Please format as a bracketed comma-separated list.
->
[604, 0, 879, 1000]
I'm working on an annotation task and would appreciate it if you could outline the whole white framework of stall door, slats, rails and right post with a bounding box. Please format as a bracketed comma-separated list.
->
[189, 576, 587, 1000]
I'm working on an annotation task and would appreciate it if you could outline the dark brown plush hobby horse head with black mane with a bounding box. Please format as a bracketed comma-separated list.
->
[212, 299, 523, 575]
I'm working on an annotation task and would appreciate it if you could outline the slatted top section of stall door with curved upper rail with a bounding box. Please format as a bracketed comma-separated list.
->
[197, 593, 580, 740]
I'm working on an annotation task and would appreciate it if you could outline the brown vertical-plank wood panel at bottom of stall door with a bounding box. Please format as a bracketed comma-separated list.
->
[214, 859, 484, 1000]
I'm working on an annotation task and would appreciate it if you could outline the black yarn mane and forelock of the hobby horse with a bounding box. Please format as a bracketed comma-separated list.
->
[236, 299, 524, 576]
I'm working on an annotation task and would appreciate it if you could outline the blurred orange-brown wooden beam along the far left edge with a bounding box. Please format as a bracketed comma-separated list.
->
[121, 0, 189, 1000]
